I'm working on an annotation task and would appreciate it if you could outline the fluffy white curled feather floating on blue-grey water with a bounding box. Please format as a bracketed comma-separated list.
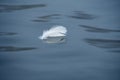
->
[39, 26, 67, 40]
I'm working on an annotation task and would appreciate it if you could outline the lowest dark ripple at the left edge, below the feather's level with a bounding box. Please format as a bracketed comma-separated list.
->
[0, 46, 37, 52]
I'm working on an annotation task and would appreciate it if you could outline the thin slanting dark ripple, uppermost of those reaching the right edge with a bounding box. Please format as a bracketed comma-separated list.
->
[80, 25, 120, 33]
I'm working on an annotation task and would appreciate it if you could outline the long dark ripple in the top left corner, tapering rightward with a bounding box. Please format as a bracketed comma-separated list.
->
[0, 4, 46, 12]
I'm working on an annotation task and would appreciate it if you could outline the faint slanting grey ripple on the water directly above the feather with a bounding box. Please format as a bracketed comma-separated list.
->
[33, 14, 61, 22]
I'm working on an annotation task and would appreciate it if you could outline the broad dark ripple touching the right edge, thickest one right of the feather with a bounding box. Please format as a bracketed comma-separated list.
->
[85, 39, 120, 49]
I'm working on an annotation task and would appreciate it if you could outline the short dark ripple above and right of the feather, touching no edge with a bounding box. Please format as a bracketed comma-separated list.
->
[68, 11, 96, 20]
